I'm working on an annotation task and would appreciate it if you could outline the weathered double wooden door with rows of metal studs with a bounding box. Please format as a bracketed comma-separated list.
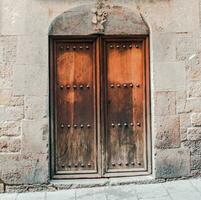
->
[50, 36, 150, 178]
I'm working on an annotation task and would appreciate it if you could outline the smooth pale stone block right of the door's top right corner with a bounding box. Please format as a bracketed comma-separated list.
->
[152, 32, 176, 62]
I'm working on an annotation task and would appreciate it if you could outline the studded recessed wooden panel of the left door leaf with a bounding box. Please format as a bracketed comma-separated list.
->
[56, 41, 97, 174]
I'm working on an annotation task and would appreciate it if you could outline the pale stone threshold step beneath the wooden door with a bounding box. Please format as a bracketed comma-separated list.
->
[50, 175, 156, 189]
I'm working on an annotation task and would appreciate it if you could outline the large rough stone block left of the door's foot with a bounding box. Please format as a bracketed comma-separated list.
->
[0, 151, 49, 184]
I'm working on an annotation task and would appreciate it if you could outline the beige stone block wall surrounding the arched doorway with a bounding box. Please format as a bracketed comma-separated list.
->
[0, 0, 201, 189]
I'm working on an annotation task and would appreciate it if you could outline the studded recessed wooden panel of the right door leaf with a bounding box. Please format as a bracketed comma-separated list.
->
[105, 40, 146, 173]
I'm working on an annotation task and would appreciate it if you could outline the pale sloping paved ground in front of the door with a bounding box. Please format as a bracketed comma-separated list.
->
[0, 179, 201, 200]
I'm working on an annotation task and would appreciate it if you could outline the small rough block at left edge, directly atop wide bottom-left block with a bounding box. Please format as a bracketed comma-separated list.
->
[0, 138, 21, 153]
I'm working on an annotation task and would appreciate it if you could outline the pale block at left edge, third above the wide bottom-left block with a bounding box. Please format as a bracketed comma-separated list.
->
[0, 106, 24, 122]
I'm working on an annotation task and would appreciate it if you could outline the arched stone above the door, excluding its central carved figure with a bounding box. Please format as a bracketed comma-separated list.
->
[49, 5, 149, 35]
